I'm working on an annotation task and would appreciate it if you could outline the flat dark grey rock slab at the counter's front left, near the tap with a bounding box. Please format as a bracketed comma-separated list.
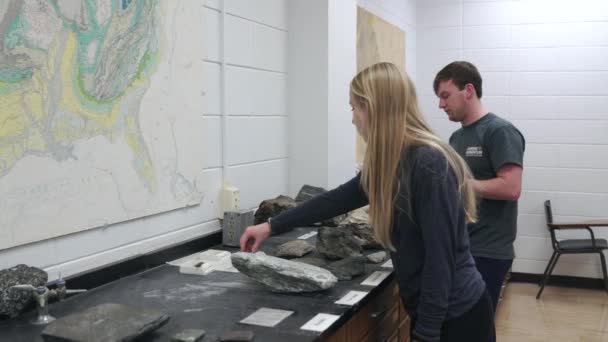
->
[42, 303, 169, 341]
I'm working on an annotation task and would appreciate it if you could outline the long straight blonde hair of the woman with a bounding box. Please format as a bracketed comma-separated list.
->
[350, 63, 477, 250]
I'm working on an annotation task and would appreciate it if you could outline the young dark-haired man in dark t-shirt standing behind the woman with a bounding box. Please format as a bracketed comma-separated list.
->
[433, 62, 525, 318]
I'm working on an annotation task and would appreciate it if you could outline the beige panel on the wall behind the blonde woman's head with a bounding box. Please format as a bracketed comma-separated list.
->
[356, 7, 405, 164]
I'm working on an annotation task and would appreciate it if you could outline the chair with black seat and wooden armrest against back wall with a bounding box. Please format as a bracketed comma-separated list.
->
[536, 200, 608, 299]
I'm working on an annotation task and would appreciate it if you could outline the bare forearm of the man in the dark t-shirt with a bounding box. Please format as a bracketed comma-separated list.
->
[473, 164, 523, 201]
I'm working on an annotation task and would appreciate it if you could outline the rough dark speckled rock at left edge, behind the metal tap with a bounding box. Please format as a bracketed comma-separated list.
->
[0, 264, 48, 318]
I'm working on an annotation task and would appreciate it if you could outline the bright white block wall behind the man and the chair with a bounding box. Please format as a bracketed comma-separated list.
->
[417, 0, 608, 278]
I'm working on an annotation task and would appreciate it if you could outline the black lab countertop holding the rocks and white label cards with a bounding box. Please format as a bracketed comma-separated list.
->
[0, 228, 393, 342]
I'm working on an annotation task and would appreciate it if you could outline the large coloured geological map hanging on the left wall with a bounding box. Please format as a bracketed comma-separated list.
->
[0, 0, 204, 249]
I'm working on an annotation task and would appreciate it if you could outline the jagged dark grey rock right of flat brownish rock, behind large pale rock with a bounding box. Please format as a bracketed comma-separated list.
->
[317, 227, 362, 260]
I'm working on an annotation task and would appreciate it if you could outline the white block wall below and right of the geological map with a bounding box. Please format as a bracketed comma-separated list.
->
[0, 0, 288, 280]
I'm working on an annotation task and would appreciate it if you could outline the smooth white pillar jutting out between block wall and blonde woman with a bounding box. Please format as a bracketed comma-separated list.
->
[287, 0, 357, 196]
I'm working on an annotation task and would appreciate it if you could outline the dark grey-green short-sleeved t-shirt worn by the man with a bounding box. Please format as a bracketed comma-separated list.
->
[450, 113, 526, 260]
